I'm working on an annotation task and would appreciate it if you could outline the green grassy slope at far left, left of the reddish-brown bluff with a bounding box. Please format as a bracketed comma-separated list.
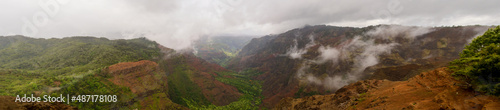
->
[0, 36, 160, 109]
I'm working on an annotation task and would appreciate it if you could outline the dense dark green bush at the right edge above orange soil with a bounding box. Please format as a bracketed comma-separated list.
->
[450, 26, 500, 95]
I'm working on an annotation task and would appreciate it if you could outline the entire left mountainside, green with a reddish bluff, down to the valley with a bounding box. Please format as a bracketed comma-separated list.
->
[0, 36, 262, 109]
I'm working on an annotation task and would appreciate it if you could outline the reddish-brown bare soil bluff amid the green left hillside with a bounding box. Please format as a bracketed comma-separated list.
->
[104, 60, 187, 109]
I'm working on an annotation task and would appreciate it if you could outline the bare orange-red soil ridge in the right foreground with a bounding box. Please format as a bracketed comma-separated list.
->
[276, 68, 500, 110]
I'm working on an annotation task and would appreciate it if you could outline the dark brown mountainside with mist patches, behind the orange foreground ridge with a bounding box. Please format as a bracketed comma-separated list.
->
[228, 25, 490, 107]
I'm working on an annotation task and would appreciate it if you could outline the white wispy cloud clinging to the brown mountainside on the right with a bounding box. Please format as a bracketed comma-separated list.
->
[296, 28, 400, 90]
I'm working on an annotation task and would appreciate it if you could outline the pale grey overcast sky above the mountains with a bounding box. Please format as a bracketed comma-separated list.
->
[0, 0, 500, 49]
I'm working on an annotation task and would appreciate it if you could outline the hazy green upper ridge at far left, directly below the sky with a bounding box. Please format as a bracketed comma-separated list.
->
[0, 36, 160, 70]
